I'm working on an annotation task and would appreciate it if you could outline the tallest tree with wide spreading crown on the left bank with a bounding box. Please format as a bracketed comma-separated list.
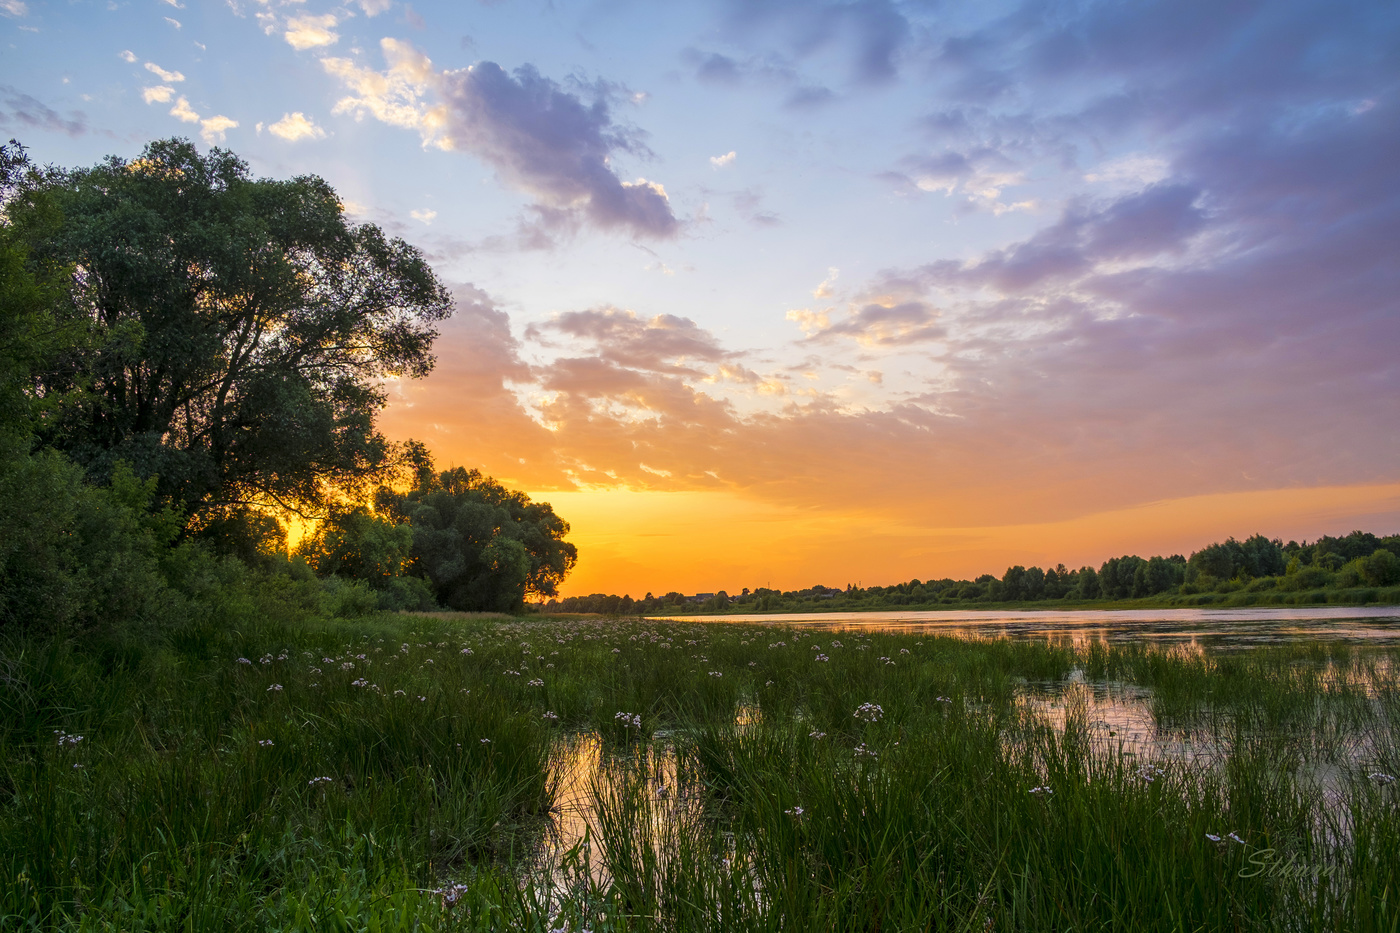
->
[6, 139, 451, 524]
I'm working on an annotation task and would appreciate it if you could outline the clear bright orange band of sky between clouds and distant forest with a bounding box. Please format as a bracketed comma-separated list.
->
[531, 483, 1400, 597]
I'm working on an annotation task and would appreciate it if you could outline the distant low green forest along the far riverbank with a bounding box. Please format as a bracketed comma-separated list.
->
[545, 531, 1400, 615]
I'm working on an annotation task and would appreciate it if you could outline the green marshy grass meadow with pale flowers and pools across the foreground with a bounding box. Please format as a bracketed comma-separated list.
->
[0, 614, 1400, 933]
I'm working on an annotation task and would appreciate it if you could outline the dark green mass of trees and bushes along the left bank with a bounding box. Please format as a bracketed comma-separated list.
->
[0, 140, 577, 632]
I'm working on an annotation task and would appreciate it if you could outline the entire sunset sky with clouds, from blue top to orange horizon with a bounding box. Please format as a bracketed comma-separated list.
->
[0, 0, 1400, 597]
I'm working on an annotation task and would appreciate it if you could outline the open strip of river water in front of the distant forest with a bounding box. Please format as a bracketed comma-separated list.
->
[651, 607, 1400, 649]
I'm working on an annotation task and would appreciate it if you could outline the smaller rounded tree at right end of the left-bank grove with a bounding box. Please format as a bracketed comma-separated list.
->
[377, 467, 578, 612]
